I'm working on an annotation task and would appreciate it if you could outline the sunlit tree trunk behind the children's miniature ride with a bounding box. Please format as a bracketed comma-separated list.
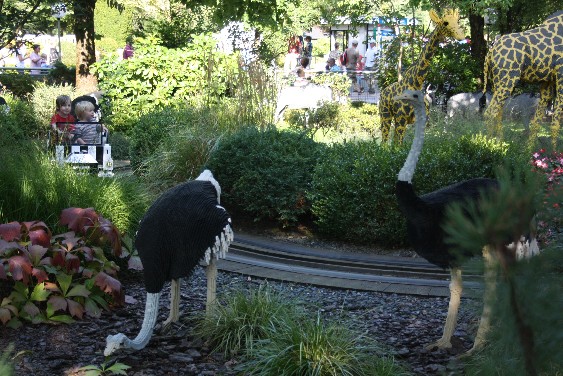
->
[73, 0, 97, 91]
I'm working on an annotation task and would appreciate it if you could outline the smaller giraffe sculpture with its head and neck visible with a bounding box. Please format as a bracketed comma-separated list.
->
[379, 9, 465, 142]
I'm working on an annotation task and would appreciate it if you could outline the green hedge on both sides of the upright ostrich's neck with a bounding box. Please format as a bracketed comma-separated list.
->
[308, 133, 526, 246]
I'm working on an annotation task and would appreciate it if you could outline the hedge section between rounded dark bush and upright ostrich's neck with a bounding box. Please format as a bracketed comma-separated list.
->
[308, 141, 407, 245]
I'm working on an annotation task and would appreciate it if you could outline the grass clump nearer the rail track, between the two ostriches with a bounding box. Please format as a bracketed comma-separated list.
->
[195, 286, 302, 356]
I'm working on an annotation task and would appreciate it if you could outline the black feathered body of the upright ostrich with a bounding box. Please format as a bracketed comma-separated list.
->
[396, 178, 498, 269]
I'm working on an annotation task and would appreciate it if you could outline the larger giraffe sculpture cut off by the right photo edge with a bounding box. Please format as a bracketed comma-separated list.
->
[484, 11, 563, 142]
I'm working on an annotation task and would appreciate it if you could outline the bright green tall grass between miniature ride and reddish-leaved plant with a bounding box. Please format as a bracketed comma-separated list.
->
[0, 143, 149, 231]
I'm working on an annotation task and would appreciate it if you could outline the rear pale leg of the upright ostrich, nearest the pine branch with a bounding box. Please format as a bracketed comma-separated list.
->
[464, 246, 496, 355]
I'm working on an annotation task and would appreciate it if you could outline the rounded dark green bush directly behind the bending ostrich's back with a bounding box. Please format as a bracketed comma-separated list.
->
[209, 128, 320, 226]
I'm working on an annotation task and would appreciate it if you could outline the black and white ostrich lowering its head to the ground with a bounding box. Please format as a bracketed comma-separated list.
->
[104, 170, 233, 356]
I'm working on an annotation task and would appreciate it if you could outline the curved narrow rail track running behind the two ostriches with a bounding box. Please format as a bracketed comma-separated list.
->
[218, 240, 482, 296]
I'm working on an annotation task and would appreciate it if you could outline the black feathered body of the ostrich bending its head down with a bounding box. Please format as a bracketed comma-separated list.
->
[135, 180, 230, 293]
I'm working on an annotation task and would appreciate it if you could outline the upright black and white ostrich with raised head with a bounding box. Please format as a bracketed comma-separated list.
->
[394, 90, 539, 352]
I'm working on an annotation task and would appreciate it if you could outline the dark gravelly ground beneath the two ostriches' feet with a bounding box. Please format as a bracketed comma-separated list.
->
[0, 268, 478, 376]
